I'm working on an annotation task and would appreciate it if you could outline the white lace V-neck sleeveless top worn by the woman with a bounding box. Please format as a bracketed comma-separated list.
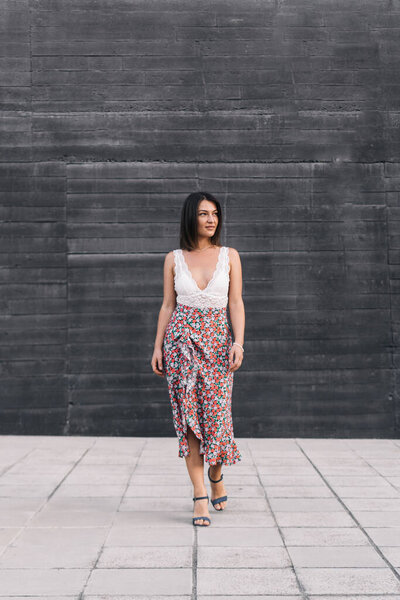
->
[173, 246, 229, 308]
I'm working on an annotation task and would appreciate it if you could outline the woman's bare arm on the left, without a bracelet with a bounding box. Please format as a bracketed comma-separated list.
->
[151, 252, 176, 377]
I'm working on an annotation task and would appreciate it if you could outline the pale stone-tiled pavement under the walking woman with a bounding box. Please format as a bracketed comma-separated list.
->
[0, 436, 400, 600]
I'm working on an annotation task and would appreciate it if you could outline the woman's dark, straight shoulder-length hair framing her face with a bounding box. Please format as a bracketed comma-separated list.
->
[179, 192, 222, 252]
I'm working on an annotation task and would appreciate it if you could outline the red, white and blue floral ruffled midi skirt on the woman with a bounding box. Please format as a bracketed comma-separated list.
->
[163, 303, 242, 465]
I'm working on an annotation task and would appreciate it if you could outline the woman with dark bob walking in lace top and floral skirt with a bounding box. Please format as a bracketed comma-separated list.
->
[151, 192, 245, 526]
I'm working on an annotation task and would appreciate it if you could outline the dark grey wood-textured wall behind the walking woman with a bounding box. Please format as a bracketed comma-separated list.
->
[0, 0, 400, 437]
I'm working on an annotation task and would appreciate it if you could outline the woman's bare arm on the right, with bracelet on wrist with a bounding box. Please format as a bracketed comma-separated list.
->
[228, 248, 245, 371]
